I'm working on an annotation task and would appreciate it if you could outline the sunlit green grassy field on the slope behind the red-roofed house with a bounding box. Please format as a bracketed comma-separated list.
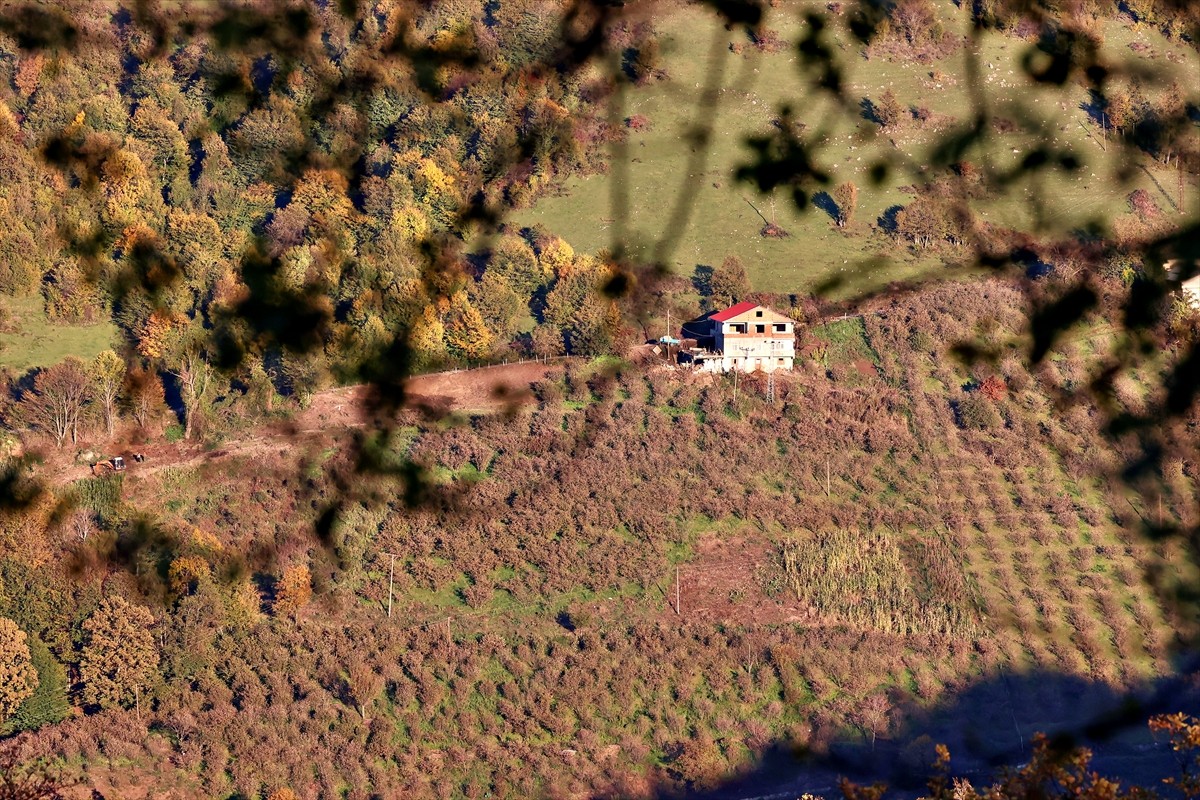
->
[515, 4, 1195, 295]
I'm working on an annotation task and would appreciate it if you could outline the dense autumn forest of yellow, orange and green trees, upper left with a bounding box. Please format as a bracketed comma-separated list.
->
[0, 2, 647, 417]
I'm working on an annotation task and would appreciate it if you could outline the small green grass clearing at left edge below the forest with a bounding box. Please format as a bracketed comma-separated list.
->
[0, 296, 116, 373]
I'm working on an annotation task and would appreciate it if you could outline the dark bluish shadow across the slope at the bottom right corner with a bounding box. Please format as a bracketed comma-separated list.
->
[660, 672, 1200, 800]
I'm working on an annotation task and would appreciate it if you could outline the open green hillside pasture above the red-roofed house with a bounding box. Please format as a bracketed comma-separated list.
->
[515, 2, 1200, 297]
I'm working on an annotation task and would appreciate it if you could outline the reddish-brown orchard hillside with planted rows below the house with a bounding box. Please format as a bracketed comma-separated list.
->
[0, 282, 1200, 796]
